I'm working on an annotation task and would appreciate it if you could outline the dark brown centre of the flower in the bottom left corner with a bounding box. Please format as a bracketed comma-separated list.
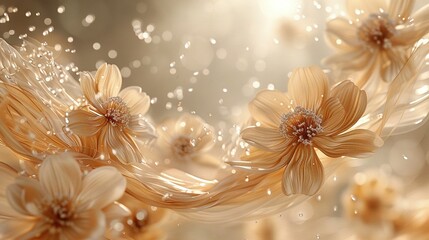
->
[42, 199, 75, 233]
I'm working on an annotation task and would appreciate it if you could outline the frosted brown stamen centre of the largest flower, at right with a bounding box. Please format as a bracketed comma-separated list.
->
[279, 106, 323, 145]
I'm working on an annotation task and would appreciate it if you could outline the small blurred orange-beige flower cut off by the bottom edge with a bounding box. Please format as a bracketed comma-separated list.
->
[107, 194, 168, 240]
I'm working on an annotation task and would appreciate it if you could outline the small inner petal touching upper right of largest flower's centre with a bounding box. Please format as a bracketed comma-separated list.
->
[320, 97, 346, 136]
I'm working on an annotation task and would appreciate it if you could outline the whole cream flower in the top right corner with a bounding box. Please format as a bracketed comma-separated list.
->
[326, 0, 429, 87]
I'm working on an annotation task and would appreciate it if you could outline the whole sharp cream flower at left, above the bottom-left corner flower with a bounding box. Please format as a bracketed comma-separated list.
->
[67, 64, 154, 163]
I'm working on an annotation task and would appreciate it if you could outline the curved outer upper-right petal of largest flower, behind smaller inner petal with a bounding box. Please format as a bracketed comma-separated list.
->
[331, 80, 367, 133]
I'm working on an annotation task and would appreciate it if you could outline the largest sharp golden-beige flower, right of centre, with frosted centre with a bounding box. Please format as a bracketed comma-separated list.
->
[232, 67, 382, 195]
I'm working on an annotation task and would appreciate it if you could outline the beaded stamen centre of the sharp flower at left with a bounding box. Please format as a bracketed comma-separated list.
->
[104, 97, 131, 129]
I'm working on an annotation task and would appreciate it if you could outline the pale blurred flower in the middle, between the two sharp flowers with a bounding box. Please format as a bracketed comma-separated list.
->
[157, 113, 219, 165]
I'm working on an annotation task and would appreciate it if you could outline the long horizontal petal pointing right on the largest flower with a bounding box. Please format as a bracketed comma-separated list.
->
[313, 129, 383, 158]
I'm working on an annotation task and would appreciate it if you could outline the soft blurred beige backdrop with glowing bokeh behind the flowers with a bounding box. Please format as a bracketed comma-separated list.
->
[0, 0, 429, 240]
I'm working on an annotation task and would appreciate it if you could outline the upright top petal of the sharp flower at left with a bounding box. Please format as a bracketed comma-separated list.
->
[95, 63, 122, 99]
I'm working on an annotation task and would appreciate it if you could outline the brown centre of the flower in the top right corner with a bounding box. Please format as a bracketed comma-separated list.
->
[357, 14, 396, 49]
